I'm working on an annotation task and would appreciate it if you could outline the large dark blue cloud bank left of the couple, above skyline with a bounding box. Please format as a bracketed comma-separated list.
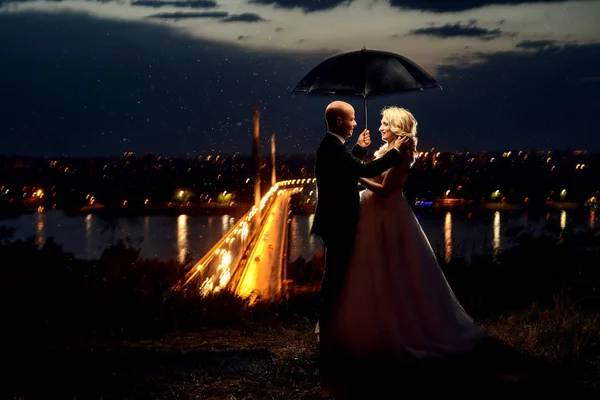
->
[0, 9, 310, 155]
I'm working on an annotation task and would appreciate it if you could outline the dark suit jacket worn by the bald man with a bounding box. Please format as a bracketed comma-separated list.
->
[311, 133, 402, 241]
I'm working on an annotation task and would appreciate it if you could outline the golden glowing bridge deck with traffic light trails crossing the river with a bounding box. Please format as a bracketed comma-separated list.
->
[177, 178, 315, 298]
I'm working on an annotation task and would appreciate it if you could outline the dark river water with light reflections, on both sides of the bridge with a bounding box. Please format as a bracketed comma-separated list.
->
[0, 209, 596, 262]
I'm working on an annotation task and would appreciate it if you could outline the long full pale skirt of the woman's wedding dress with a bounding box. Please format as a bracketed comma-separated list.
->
[330, 172, 486, 358]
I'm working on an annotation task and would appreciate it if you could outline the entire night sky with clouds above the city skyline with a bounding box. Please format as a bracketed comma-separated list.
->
[0, 0, 600, 156]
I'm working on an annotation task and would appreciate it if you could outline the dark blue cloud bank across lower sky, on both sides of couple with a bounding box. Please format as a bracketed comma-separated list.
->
[0, 9, 600, 155]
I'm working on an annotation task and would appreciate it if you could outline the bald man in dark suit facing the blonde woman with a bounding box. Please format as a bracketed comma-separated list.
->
[311, 101, 408, 349]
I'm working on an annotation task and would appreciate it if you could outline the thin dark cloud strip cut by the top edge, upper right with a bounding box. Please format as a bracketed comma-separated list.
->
[390, 0, 569, 13]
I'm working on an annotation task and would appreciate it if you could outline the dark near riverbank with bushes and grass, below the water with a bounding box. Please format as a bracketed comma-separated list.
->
[0, 225, 600, 399]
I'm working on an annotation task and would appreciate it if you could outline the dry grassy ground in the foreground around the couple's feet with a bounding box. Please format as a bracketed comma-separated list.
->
[5, 302, 600, 400]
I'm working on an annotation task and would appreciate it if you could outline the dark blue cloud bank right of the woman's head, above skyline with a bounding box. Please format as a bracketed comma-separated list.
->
[398, 44, 600, 151]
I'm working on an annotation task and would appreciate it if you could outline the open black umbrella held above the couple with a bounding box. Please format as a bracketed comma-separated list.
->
[292, 48, 442, 127]
